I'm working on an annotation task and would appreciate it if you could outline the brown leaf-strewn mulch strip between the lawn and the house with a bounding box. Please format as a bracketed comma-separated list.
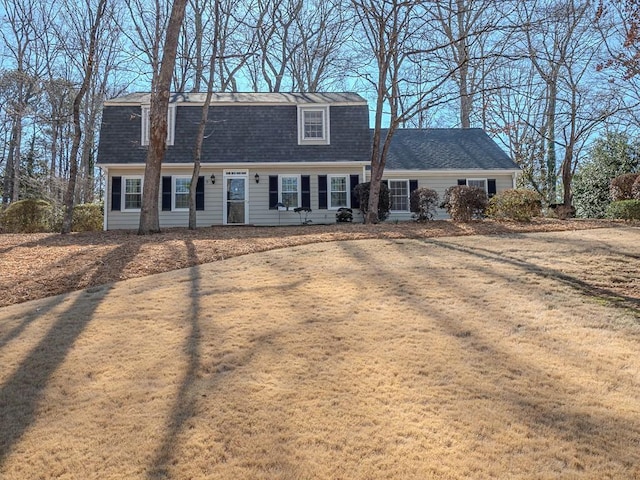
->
[0, 219, 636, 306]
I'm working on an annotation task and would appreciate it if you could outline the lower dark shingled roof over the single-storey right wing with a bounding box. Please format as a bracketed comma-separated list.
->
[383, 128, 520, 170]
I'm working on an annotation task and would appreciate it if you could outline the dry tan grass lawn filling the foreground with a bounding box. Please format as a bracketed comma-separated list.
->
[0, 228, 640, 479]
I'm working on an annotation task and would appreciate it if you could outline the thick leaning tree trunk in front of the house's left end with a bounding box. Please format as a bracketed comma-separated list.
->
[138, 0, 187, 235]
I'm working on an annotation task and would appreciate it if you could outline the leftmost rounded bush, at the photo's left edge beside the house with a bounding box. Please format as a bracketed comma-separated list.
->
[1, 199, 55, 233]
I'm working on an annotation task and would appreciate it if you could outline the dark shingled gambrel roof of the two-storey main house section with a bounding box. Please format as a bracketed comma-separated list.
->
[98, 92, 371, 164]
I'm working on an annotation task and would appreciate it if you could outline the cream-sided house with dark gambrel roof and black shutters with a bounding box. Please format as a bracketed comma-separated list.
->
[98, 93, 519, 229]
